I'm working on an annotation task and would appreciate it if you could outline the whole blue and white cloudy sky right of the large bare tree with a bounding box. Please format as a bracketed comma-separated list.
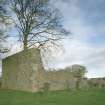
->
[0, 0, 105, 77]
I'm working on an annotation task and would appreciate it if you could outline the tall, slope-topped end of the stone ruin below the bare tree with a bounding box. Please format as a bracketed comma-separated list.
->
[2, 49, 43, 91]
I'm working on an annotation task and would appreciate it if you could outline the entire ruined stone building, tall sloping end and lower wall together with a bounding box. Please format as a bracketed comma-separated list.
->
[2, 48, 87, 92]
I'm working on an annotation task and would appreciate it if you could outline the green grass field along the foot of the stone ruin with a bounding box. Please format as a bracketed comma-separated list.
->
[0, 89, 105, 105]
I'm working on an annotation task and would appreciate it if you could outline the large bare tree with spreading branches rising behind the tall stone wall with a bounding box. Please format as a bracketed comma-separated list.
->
[10, 0, 69, 50]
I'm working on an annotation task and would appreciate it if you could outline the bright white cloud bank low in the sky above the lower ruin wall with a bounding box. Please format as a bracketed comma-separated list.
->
[49, 40, 105, 77]
